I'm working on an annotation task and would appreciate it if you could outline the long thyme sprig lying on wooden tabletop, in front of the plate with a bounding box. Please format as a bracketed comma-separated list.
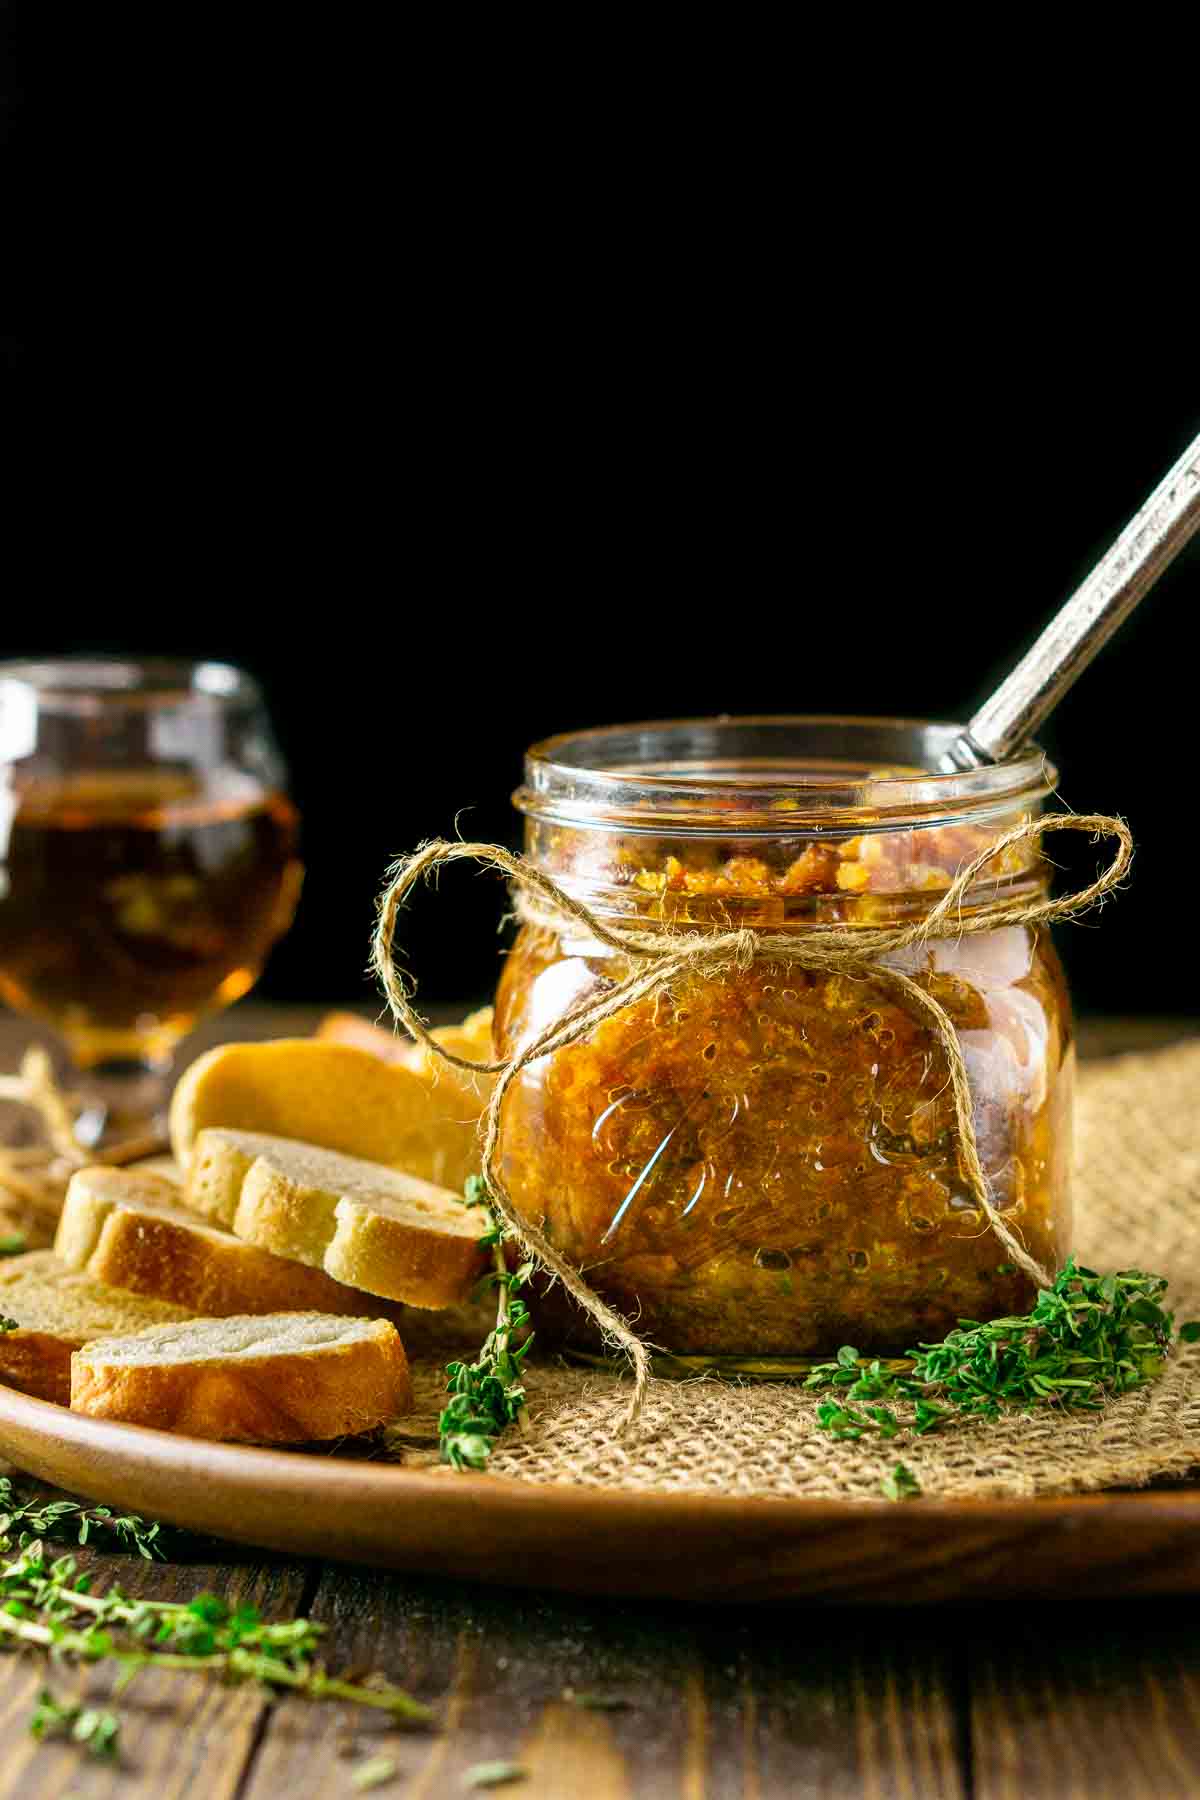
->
[0, 1541, 432, 1751]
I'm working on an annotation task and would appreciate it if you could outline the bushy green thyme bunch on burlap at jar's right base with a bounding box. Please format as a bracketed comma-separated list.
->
[806, 1256, 1200, 1440]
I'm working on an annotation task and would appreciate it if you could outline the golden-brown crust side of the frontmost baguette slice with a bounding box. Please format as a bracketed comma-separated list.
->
[70, 1319, 412, 1444]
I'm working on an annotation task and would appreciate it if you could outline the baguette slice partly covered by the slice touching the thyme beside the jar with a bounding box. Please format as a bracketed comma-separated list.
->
[54, 1166, 408, 1318]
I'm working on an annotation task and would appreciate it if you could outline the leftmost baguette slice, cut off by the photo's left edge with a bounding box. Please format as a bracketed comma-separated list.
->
[0, 1249, 194, 1406]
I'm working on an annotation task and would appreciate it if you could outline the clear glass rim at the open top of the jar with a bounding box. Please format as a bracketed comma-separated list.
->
[513, 713, 1058, 837]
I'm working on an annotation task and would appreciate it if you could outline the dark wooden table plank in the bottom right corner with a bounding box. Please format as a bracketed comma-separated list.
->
[966, 1602, 1200, 1800]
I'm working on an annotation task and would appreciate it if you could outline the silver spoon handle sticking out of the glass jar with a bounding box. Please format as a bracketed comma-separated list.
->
[941, 437, 1200, 774]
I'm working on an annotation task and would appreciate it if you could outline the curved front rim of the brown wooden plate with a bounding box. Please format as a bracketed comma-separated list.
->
[0, 1388, 1200, 1604]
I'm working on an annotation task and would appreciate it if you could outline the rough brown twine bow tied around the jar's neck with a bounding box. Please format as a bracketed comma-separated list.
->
[371, 814, 1133, 1429]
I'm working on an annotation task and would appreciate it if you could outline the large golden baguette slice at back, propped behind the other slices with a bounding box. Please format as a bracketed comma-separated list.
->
[169, 1037, 484, 1192]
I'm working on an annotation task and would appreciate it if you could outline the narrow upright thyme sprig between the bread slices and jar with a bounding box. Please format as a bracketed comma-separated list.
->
[437, 1175, 533, 1469]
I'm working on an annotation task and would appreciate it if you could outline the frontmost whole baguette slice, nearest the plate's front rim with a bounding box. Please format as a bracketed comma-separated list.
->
[70, 1312, 412, 1444]
